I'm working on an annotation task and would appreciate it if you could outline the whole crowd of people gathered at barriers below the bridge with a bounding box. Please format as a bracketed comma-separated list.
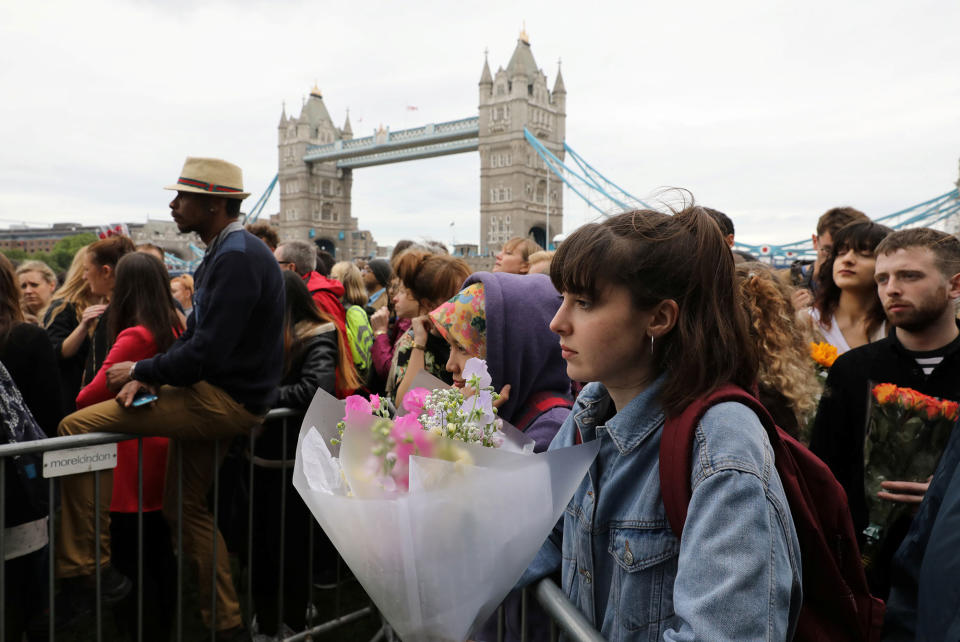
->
[0, 158, 960, 640]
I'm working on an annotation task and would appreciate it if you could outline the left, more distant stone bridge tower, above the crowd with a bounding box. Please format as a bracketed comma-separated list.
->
[273, 86, 377, 259]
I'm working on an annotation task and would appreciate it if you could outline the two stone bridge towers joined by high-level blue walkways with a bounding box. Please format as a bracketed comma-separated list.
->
[274, 31, 567, 258]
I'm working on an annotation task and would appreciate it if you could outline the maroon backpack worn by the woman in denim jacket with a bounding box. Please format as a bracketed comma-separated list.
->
[660, 384, 886, 642]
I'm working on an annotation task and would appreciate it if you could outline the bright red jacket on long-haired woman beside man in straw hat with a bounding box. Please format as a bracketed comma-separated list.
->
[77, 325, 170, 513]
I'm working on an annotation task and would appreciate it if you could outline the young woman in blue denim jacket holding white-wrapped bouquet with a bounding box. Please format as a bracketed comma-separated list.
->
[521, 207, 801, 640]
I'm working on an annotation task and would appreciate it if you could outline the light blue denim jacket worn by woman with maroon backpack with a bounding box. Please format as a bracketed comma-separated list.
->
[520, 378, 801, 641]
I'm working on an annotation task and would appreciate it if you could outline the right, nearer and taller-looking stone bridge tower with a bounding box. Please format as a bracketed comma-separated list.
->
[478, 30, 567, 254]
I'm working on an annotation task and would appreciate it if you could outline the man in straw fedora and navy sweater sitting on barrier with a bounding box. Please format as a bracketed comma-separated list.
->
[57, 158, 284, 639]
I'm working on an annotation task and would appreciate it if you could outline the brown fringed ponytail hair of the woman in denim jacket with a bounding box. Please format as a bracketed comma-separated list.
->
[550, 205, 757, 415]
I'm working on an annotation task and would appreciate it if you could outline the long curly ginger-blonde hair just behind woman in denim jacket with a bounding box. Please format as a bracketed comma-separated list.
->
[736, 262, 821, 441]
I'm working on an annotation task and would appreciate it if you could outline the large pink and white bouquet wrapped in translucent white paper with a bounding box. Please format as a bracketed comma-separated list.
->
[294, 358, 599, 642]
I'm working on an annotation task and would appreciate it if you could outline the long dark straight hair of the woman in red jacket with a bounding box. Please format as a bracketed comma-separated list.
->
[107, 252, 183, 352]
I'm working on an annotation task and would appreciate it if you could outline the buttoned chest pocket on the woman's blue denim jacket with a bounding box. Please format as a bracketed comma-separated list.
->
[607, 525, 680, 640]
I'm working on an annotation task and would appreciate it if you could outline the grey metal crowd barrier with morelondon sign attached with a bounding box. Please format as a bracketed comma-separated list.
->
[0, 408, 603, 642]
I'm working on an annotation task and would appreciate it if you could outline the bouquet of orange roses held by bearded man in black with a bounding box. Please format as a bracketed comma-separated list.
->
[863, 383, 960, 569]
